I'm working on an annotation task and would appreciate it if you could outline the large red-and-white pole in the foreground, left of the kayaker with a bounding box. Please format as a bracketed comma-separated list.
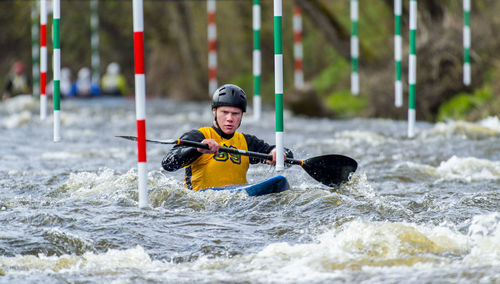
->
[132, 0, 148, 208]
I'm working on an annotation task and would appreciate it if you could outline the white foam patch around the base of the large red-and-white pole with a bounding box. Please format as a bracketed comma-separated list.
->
[56, 168, 248, 211]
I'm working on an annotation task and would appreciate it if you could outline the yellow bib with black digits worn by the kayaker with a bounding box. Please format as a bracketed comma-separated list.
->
[185, 127, 250, 191]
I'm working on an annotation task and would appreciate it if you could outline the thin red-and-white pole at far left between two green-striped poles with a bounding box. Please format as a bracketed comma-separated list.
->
[40, 0, 47, 120]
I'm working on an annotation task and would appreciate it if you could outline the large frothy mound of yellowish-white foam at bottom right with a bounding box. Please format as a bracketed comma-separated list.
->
[222, 217, 500, 283]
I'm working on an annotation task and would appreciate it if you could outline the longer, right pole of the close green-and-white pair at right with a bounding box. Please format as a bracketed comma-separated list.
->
[408, 0, 417, 138]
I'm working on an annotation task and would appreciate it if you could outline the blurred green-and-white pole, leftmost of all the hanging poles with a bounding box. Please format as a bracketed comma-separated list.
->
[31, 0, 40, 97]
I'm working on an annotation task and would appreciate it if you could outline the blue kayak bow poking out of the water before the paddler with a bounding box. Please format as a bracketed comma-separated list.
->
[200, 176, 290, 196]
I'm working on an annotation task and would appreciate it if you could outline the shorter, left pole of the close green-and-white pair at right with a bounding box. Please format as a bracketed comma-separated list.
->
[394, 0, 403, 107]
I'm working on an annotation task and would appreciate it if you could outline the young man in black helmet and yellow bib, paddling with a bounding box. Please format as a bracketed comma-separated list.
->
[162, 84, 293, 191]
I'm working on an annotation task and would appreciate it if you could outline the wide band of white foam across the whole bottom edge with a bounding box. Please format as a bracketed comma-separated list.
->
[0, 216, 500, 283]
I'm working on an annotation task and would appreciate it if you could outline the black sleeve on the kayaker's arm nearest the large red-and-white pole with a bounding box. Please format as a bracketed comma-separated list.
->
[161, 130, 205, 172]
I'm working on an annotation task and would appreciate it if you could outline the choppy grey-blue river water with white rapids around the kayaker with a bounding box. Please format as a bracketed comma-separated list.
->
[0, 97, 500, 283]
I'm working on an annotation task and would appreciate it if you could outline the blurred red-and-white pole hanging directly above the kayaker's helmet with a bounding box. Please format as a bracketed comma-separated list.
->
[207, 0, 217, 96]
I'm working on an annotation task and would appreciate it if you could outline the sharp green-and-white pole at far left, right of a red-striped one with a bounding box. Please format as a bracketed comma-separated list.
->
[52, 0, 61, 142]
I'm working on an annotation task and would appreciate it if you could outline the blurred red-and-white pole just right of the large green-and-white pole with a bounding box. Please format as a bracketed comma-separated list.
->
[293, 6, 304, 89]
